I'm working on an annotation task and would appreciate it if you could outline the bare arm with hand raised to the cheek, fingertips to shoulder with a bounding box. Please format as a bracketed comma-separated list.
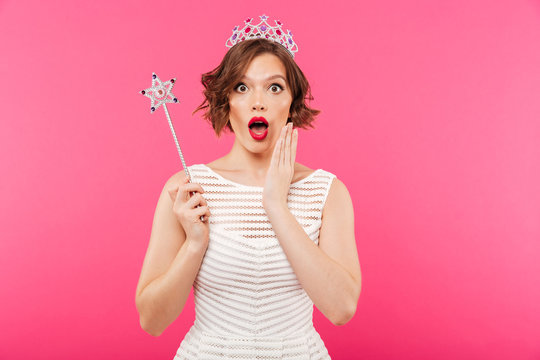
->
[263, 123, 361, 325]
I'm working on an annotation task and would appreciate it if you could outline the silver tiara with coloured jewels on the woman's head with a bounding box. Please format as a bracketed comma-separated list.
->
[225, 15, 298, 59]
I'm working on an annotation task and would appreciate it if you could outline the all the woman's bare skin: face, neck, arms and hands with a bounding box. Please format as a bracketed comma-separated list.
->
[135, 54, 361, 336]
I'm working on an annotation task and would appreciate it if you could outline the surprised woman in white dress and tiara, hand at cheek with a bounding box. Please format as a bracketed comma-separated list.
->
[136, 16, 361, 359]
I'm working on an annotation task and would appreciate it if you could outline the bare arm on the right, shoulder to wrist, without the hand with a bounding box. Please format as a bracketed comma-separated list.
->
[267, 179, 361, 325]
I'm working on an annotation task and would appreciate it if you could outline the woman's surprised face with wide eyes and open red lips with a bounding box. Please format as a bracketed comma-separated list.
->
[229, 53, 292, 152]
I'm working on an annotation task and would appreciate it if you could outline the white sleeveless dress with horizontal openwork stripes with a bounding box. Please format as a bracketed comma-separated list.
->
[174, 164, 335, 360]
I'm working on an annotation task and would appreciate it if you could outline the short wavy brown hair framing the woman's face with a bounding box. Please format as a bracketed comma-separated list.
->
[192, 38, 320, 137]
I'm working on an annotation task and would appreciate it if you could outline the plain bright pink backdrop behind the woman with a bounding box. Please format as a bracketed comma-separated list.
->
[0, 0, 540, 360]
